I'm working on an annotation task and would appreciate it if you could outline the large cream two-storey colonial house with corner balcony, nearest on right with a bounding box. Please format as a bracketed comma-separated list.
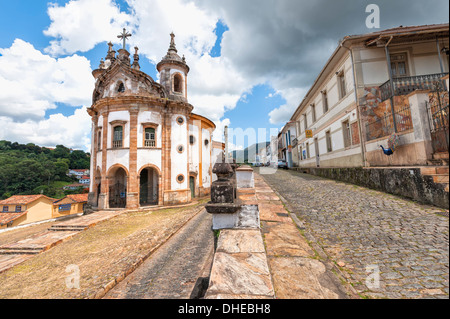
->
[290, 23, 449, 168]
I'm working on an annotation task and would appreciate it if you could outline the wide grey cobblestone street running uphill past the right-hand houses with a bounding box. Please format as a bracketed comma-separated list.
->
[261, 170, 449, 298]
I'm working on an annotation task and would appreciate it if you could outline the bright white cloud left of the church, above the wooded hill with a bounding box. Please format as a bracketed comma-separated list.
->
[0, 39, 94, 120]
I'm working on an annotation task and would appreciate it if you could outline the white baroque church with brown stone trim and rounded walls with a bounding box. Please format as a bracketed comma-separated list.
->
[88, 29, 223, 209]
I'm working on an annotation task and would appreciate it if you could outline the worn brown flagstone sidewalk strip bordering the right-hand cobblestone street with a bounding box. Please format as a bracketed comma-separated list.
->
[238, 172, 357, 299]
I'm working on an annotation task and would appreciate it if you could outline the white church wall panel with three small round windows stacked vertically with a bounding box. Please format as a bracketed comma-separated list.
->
[171, 115, 189, 190]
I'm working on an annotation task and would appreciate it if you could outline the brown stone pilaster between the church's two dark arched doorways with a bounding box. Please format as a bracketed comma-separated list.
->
[127, 106, 139, 209]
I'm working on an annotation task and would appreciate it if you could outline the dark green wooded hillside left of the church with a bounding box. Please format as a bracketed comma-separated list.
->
[0, 140, 90, 199]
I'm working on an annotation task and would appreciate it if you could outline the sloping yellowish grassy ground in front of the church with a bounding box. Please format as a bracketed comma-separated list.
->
[0, 202, 204, 299]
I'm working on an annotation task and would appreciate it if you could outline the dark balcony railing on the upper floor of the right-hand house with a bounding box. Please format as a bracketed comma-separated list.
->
[380, 73, 448, 101]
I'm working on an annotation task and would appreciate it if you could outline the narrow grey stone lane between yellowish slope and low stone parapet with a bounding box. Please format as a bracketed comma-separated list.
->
[103, 209, 214, 299]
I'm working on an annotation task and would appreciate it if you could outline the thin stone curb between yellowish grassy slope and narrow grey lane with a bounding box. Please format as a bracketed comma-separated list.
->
[88, 207, 205, 299]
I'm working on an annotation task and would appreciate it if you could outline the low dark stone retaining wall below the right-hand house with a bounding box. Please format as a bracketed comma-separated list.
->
[299, 167, 449, 209]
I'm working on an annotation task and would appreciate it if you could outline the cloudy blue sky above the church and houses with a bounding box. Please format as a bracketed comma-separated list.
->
[0, 0, 449, 151]
